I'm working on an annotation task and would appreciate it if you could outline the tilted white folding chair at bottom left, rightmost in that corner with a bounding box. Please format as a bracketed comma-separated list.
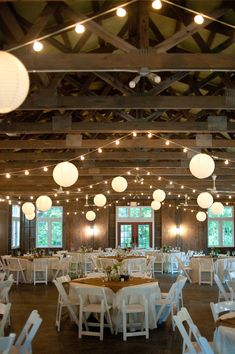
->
[13, 310, 42, 354]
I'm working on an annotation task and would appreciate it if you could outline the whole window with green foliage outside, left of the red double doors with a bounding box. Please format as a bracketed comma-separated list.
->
[36, 207, 63, 248]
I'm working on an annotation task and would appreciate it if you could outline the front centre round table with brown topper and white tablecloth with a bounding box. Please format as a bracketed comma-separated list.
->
[69, 278, 161, 329]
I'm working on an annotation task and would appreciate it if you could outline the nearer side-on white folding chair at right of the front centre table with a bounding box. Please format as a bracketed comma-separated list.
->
[155, 283, 177, 331]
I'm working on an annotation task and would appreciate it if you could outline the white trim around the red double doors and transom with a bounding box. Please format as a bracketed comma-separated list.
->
[115, 205, 155, 248]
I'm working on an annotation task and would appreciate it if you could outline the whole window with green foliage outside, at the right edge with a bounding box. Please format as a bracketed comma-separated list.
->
[208, 206, 234, 247]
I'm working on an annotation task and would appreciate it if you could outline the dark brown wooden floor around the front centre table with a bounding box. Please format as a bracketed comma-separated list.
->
[10, 275, 217, 354]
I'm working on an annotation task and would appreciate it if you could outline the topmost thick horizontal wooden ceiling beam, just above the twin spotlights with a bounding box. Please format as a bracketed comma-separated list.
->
[17, 49, 235, 72]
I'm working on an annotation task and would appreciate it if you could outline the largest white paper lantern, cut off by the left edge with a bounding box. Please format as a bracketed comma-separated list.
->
[0, 51, 29, 113]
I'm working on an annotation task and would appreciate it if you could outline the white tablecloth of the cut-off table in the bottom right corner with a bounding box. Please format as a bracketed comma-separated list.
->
[214, 326, 235, 354]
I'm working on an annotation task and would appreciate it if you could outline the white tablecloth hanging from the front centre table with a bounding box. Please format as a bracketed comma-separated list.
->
[69, 282, 161, 329]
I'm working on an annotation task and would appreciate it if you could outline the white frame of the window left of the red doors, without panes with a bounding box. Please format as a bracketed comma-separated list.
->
[36, 205, 64, 248]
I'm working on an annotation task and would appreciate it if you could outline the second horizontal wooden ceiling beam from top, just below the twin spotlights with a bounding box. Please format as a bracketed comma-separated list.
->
[18, 94, 235, 110]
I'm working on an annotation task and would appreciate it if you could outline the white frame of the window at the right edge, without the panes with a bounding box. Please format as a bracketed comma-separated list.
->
[207, 205, 234, 248]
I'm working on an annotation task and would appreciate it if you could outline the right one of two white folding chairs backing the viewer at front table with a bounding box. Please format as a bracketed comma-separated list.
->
[116, 287, 149, 341]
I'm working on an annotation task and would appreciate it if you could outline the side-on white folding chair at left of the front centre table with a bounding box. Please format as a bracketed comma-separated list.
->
[53, 275, 79, 332]
